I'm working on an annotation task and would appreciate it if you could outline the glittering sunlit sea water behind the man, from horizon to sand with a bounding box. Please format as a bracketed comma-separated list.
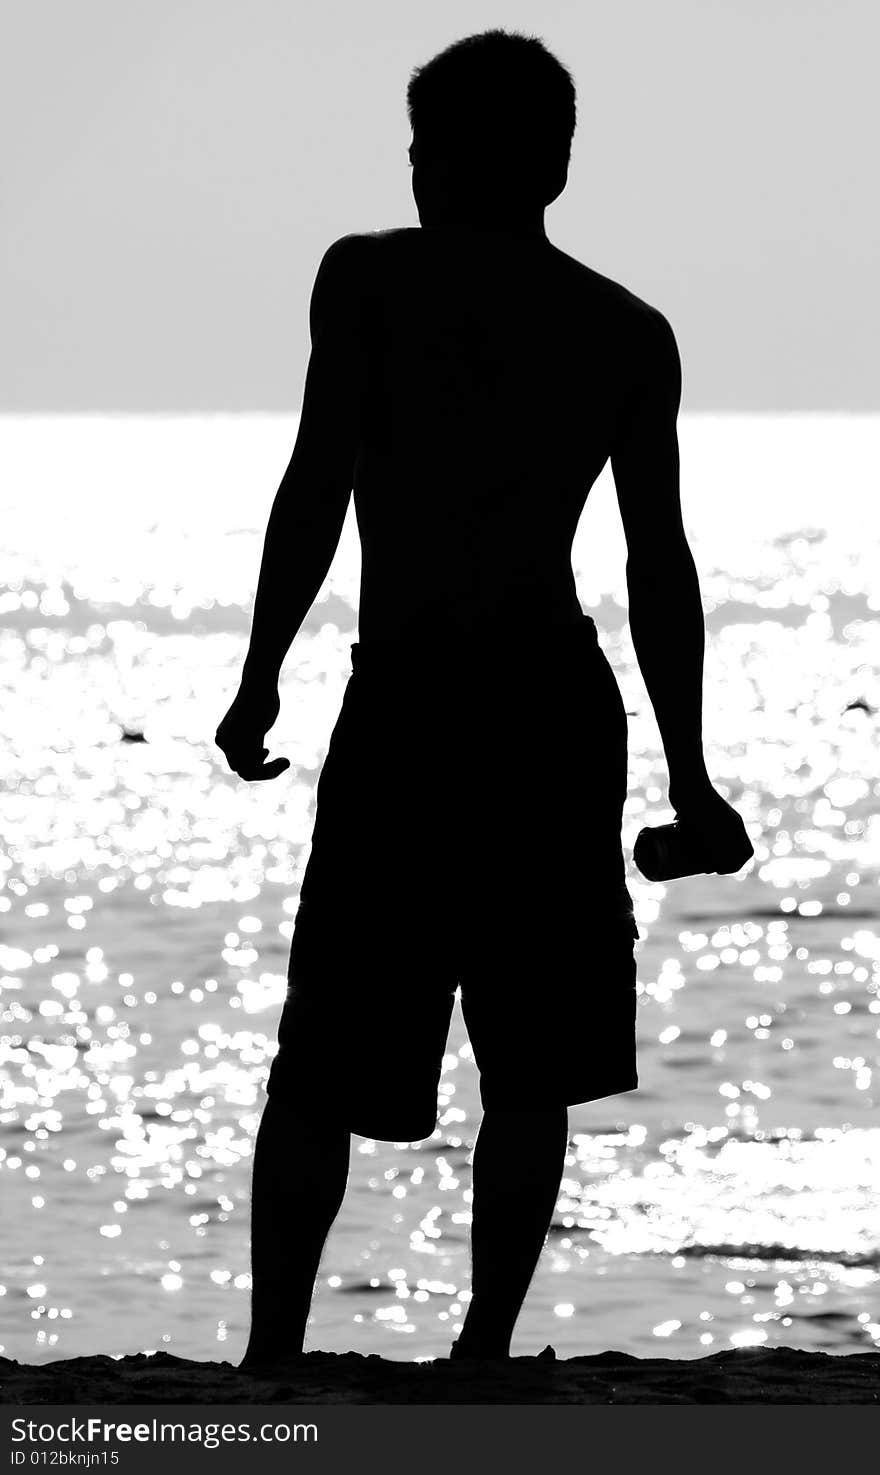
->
[0, 416, 880, 1361]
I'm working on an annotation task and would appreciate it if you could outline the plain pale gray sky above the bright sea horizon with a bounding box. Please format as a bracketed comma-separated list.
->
[0, 0, 880, 410]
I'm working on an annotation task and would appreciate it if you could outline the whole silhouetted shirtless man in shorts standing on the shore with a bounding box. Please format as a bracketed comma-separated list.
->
[217, 31, 752, 1364]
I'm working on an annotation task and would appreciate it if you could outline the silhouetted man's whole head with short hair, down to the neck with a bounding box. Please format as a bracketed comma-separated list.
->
[407, 31, 576, 223]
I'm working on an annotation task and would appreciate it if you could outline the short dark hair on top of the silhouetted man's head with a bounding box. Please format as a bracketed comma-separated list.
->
[407, 30, 576, 193]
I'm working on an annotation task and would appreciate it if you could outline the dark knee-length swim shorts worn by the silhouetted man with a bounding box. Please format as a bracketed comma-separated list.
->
[267, 617, 638, 1142]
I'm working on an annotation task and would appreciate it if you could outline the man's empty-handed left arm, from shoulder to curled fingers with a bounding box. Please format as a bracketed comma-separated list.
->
[215, 236, 366, 779]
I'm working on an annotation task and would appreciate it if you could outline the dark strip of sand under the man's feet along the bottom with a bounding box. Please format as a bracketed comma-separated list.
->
[0, 1347, 880, 1406]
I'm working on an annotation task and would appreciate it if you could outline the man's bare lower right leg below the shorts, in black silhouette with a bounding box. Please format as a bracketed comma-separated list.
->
[453, 1106, 569, 1357]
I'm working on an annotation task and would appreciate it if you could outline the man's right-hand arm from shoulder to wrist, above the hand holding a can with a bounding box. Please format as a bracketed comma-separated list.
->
[612, 308, 710, 810]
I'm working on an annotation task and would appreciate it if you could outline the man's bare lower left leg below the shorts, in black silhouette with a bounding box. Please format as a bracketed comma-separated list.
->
[242, 1096, 351, 1366]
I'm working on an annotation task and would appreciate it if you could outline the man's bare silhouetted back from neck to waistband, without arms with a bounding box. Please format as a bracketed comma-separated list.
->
[318, 226, 671, 640]
